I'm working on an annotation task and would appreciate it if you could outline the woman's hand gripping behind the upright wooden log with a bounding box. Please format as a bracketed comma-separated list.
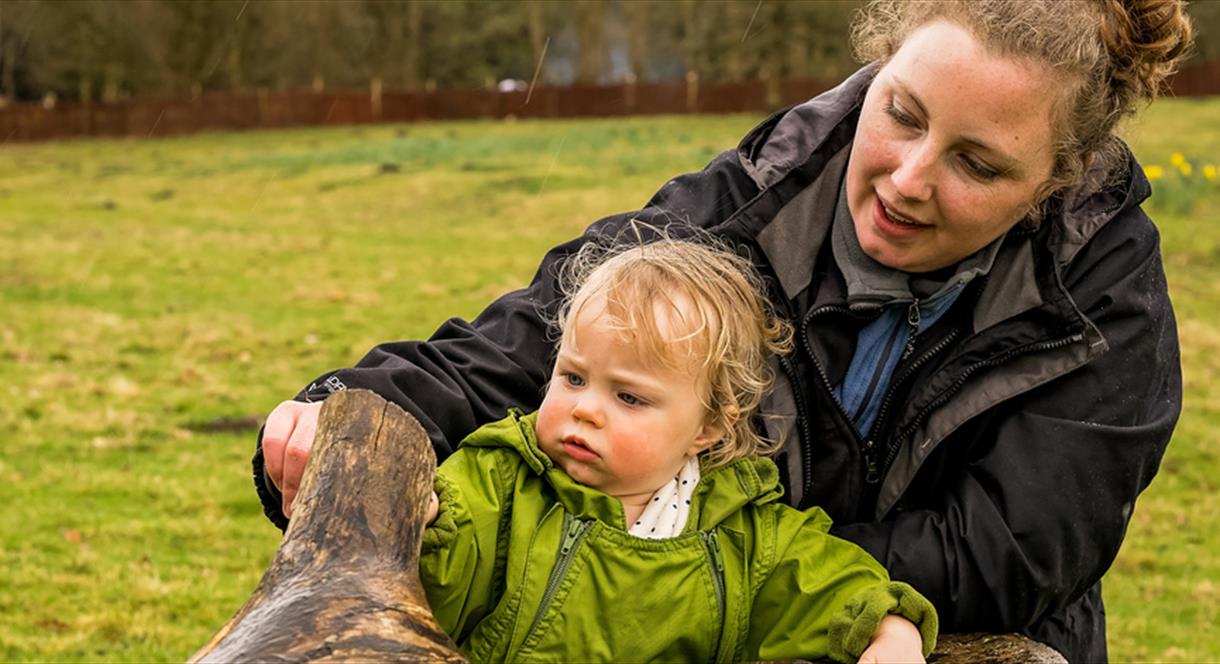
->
[262, 402, 322, 516]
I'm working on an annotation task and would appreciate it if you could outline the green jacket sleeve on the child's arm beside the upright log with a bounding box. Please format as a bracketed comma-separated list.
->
[420, 448, 521, 644]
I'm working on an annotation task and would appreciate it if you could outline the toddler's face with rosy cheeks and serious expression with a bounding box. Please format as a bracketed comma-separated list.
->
[538, 299, 722, 502]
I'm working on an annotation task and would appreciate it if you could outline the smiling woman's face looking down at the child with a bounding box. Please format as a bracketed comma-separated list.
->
[847, 21, 1058, 272]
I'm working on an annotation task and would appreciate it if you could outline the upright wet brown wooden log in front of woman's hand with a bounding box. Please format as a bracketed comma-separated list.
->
[190, 391, 464, 662]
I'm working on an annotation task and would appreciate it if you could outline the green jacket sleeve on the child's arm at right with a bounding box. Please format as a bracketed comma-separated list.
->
[745, 508, 937, 662]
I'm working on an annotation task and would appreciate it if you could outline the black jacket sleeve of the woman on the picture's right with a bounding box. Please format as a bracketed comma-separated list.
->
[834, 203, 1182, 638]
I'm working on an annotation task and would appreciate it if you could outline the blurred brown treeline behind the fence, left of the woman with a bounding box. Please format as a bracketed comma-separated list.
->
[0, 0, 878, 101]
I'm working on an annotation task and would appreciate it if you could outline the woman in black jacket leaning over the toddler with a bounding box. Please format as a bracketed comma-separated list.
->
[255, 0, 1191, 662]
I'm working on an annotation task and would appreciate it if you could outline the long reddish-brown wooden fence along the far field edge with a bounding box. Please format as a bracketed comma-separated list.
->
[0, 61, 1220, 144]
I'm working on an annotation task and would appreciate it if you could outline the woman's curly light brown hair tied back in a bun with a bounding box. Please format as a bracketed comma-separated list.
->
[852, 0, 1192, 203]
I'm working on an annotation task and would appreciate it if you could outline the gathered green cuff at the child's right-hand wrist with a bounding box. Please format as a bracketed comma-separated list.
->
[830, 581, 938, 662]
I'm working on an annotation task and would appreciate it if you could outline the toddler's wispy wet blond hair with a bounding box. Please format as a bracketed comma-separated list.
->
[554, 237, 792, 467]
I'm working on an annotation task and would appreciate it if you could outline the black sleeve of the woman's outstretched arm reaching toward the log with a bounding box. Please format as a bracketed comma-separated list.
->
[253, 151, 756, 529]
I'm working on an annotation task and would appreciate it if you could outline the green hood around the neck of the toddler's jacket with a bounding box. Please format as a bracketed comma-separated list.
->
[461, 409, 783, 531]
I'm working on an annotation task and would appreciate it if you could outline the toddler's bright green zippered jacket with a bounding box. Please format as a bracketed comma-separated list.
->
[421, 411, 937, 662]
